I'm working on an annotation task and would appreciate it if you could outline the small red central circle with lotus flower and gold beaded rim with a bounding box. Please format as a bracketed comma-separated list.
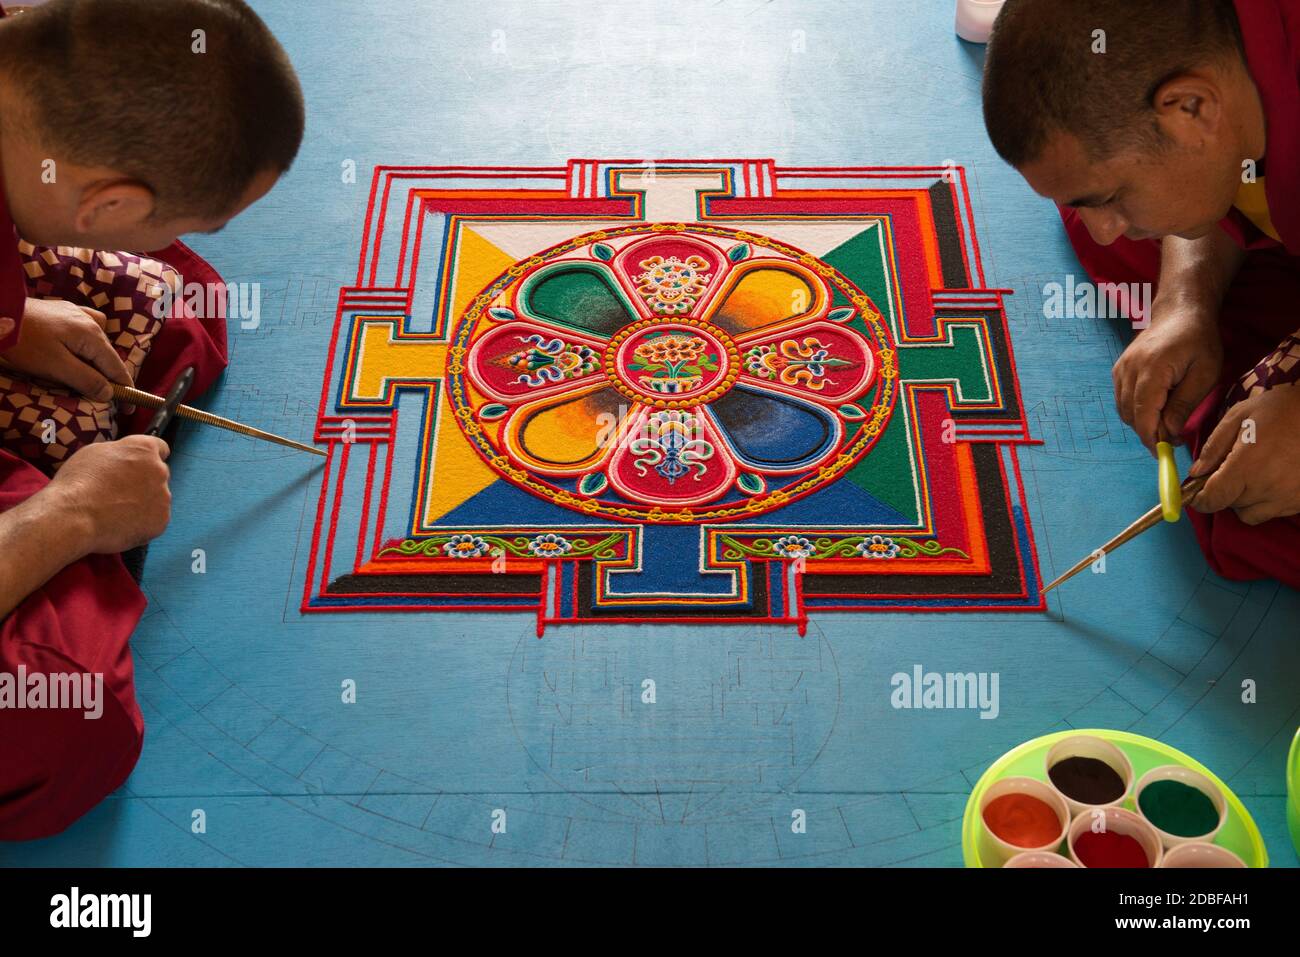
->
[605, 319, 740, 408]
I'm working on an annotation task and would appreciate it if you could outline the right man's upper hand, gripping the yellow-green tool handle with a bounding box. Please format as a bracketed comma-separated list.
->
[1110, 298, 1223, 454]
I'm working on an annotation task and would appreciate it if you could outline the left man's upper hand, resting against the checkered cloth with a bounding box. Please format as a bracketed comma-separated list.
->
[0, 299, 133, 402]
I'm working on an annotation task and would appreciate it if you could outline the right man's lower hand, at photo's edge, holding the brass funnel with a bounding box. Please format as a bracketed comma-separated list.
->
[1187, 384, 1300, 525]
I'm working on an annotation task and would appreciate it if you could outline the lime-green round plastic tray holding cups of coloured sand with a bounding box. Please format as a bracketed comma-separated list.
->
[962, 728, 1263, 867]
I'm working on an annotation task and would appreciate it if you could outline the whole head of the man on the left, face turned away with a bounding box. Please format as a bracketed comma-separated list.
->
[0, 0, 304, 251]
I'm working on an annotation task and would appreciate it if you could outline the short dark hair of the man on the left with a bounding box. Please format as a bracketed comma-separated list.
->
[0, 0, 304, 216]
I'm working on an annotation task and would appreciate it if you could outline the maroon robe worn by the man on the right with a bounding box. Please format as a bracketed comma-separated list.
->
[1061, 0, 1300, 588]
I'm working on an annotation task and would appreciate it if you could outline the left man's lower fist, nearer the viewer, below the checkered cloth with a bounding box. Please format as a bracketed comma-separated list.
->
[42, 436, 172, 554]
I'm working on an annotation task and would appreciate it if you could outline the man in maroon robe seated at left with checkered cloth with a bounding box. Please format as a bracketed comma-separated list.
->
[0, 0, 303, 840]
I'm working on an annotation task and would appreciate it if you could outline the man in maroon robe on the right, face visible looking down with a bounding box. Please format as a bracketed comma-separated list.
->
[984, 0, 1300, 588]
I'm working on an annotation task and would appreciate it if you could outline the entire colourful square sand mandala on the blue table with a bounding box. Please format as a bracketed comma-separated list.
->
[303, 161, 1043, 631]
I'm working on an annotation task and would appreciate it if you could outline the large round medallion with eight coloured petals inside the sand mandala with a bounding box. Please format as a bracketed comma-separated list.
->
[446, 222, 898, 522]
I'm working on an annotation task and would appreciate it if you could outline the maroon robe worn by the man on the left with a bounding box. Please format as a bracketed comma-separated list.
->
[0, 1, 226, 840]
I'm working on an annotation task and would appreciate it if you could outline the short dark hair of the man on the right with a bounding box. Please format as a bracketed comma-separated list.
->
[984, 0, 1244, 168]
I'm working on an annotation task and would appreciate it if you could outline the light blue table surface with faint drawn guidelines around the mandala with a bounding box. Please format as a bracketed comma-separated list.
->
[0, 0, 1300, 866]
